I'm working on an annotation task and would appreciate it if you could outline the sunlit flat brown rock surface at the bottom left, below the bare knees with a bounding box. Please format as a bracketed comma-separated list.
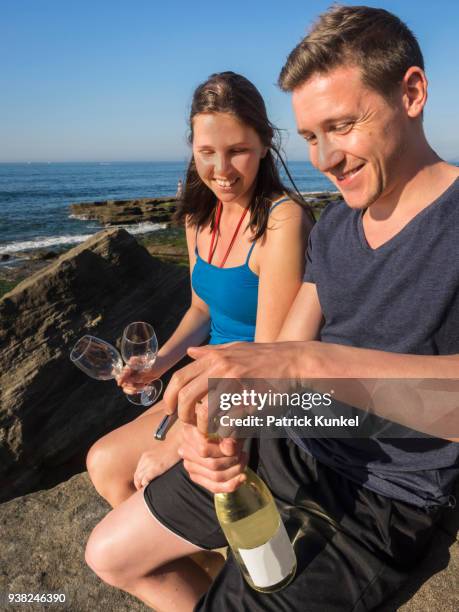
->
[0, 474, 149, 612]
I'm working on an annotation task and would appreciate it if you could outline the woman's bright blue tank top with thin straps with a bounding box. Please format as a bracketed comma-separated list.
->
[191, 198, 289, 344]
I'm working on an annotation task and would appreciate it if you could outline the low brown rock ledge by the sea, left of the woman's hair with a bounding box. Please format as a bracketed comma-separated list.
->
[70, 198, 177, 225]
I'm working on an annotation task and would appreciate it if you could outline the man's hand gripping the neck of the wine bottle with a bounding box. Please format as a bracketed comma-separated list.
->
[178, 424, 247, 493]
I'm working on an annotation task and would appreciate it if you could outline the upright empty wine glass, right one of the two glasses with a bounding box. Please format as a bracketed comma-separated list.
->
[121, 321, 163, 406]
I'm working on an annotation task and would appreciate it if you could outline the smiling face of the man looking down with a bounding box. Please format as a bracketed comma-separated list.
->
[292, 66, 407, 209]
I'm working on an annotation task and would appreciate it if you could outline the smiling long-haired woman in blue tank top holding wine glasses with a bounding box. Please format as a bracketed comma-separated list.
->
[87, 72, 313, 507]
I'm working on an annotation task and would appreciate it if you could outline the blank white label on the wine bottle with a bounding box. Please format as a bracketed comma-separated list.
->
[238, 521, 296, 588]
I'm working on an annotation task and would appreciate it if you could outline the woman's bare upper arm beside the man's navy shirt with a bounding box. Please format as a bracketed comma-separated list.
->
[255, 202, 311, 342]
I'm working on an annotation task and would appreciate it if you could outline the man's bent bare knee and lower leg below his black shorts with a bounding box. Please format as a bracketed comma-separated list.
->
[86, 491, 210, 612]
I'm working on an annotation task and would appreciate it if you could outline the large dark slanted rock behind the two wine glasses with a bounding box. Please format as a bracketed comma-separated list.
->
[0, 230, 189, 501]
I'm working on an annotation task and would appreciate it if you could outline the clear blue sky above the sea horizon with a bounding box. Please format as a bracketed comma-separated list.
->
[0, 0, 459, 162]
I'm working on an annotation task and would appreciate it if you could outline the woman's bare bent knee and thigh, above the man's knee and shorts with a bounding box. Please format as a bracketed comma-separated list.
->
[86, 401, 180, 508]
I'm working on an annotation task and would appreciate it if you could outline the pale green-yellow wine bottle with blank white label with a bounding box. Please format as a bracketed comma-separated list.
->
[215, 468, 296, 593]
